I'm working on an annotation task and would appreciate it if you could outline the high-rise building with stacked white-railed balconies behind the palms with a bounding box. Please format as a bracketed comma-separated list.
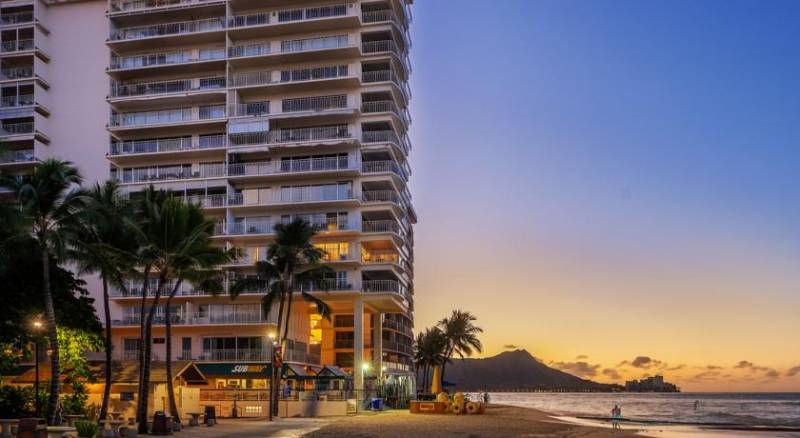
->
[0, 0, 416, 413]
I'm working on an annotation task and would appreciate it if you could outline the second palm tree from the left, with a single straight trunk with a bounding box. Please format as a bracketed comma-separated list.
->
[70, 181, 136, 419]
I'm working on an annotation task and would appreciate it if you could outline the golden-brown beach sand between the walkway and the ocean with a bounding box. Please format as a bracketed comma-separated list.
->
[305, 405, 641, 438]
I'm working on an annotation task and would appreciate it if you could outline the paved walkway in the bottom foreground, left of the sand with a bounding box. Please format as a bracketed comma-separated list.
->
[174, 418, 329, 438]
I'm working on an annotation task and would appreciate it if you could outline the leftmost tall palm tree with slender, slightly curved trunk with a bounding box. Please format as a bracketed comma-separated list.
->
[0, 159, 85, 424]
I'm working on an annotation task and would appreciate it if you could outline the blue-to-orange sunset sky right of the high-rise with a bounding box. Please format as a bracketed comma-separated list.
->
[412, 0, 800, 391]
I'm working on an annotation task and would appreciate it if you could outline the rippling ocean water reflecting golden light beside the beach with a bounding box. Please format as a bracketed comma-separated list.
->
[490, 393, 800, 428]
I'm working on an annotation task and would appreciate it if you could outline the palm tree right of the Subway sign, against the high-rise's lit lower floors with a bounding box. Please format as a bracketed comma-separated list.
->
[231, 218, 333, 413]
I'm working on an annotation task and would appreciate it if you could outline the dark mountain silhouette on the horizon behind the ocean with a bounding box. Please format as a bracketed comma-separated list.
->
[434, 350, 623, 391]
